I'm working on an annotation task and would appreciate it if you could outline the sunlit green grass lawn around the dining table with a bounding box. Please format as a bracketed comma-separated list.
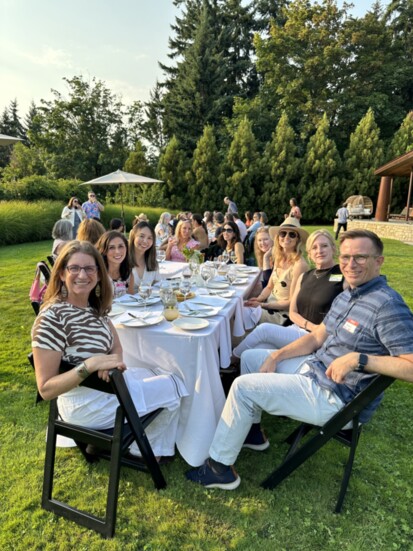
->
[0, 231, 413, 551]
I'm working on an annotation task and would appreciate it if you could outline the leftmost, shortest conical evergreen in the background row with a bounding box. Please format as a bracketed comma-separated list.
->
[158, 136, 188, 209]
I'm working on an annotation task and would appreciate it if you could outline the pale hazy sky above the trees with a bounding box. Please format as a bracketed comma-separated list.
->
[0, 0, 388, 117]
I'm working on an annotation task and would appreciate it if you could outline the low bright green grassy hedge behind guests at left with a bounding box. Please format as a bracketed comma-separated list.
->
[0, 201, 169, 245]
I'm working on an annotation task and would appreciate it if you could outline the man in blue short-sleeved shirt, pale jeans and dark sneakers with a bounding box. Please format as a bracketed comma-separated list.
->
[186, 230, 413, 490]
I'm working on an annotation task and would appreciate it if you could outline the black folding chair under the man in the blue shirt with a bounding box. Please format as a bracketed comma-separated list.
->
[261, 375, 395, 513]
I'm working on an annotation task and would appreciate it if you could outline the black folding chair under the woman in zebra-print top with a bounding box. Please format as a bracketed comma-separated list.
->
[29, 355, 166, 538]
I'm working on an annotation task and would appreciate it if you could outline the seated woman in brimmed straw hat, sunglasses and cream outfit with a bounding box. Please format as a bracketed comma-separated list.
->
[244, 218, 308, 329]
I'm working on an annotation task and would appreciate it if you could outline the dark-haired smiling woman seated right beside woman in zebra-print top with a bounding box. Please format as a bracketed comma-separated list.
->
[96, 234, 133, 298]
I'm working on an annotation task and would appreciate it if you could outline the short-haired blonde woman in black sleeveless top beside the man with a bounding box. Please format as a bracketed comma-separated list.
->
[233, 228, 345, 358]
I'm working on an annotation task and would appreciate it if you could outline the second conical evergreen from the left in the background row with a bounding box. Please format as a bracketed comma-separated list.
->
[188, 126, 222, 212]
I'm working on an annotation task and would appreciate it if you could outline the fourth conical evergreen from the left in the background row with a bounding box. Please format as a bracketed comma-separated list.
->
[258, 113, 300, 218]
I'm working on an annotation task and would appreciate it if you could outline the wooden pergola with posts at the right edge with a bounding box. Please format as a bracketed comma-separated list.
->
[374, 150, 413, 222]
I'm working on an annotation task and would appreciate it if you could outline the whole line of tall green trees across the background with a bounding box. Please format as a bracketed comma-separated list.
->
[0, 0, 413, 222]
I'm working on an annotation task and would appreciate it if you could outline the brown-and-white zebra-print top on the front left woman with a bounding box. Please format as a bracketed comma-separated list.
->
[32, 302, 113, 364]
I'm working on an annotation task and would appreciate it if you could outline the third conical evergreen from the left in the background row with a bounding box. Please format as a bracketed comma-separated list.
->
[225, 117, 260, 212]
